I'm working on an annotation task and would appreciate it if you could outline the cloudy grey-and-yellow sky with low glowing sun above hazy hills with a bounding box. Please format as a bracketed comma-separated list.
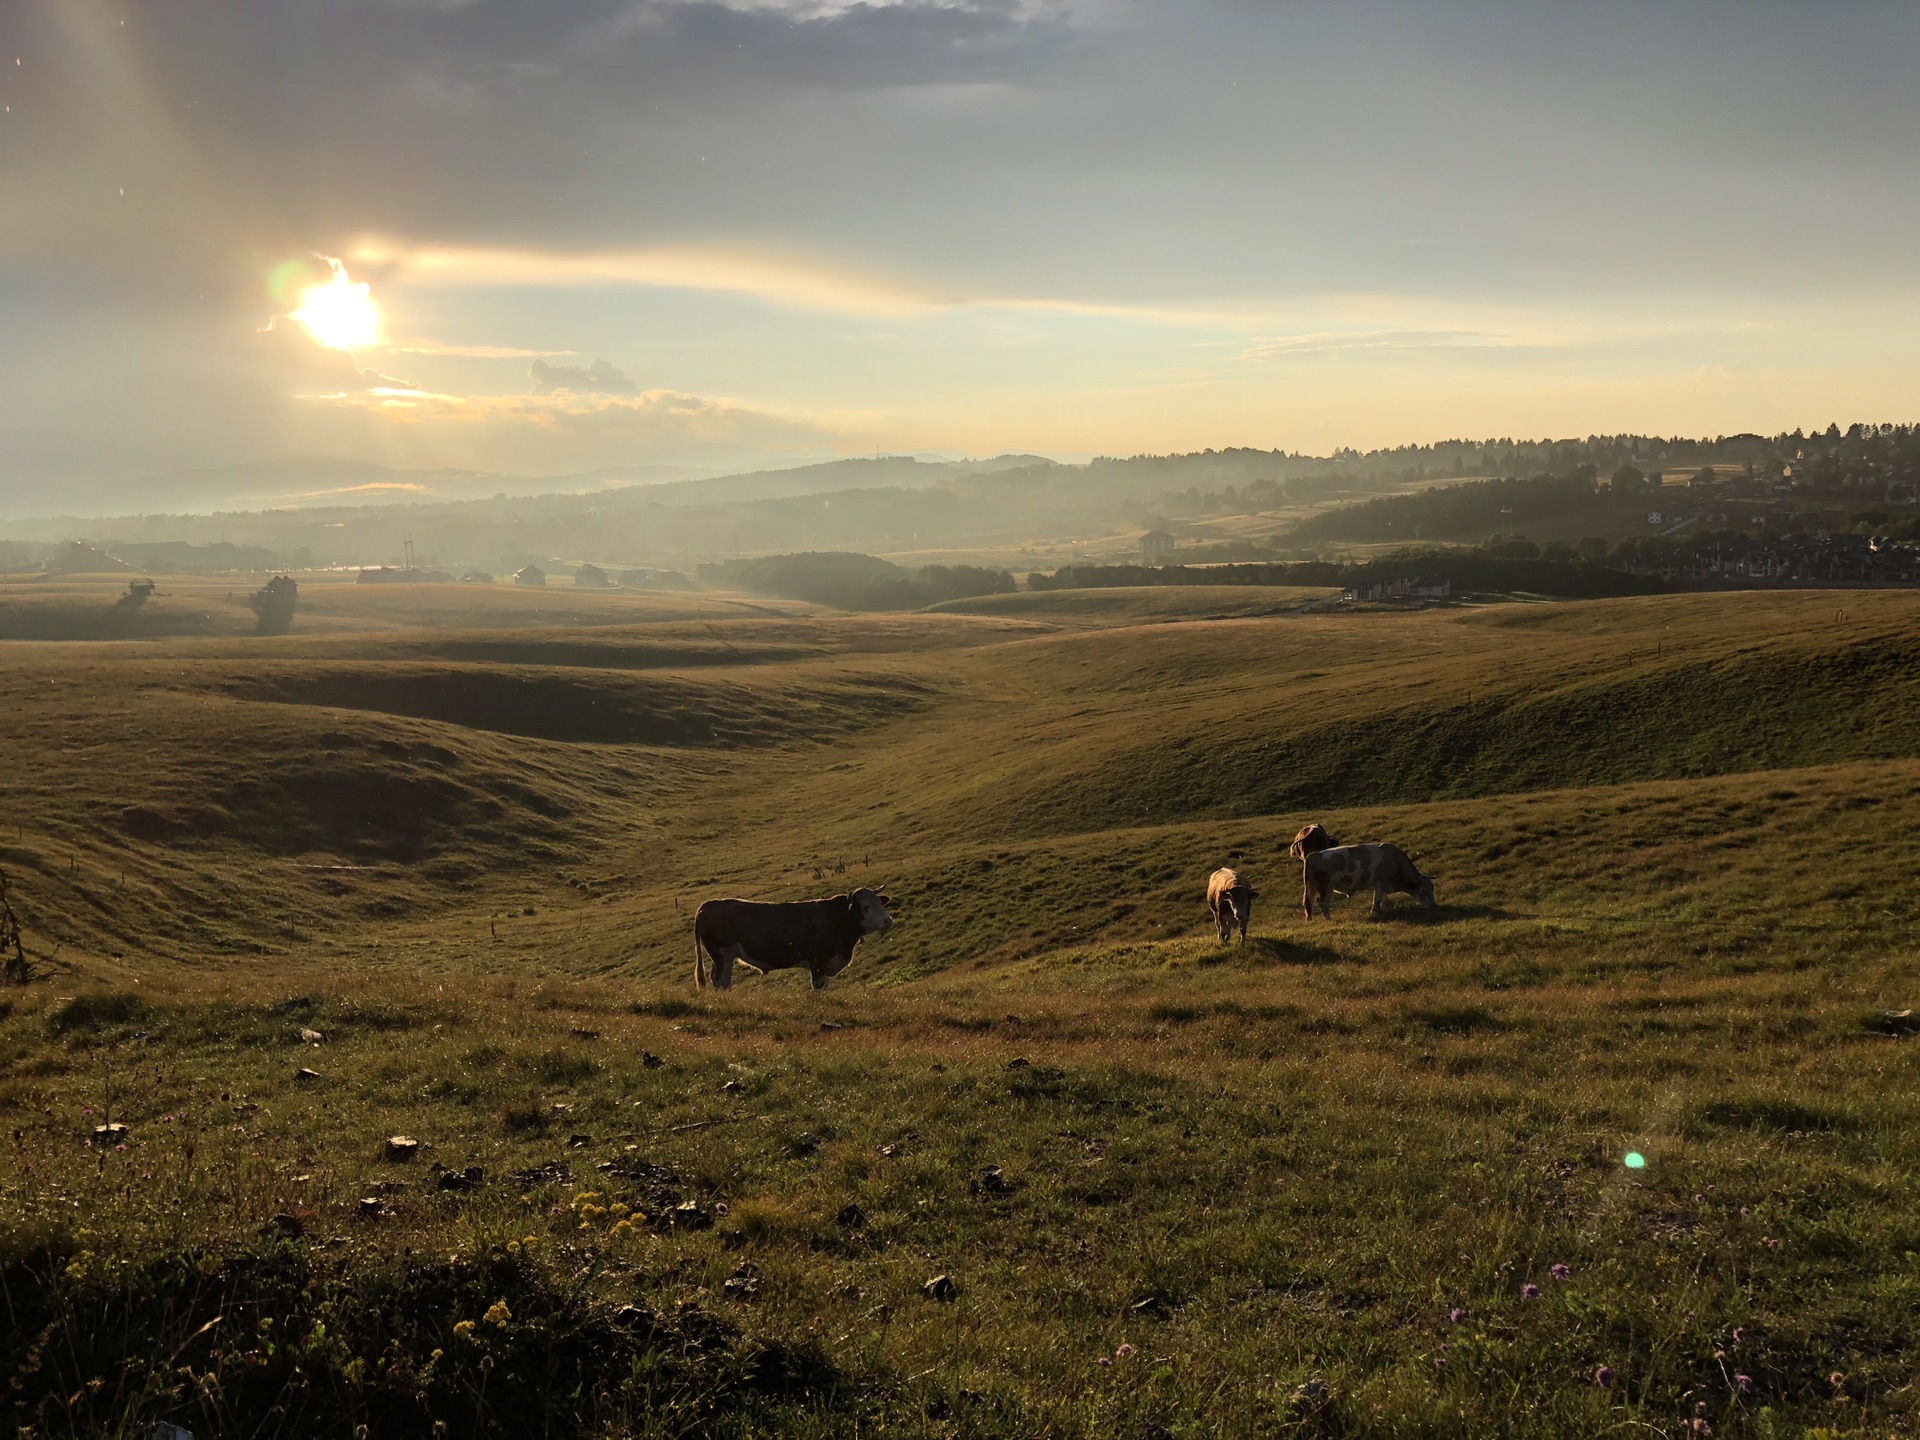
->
[0, 0, 1920, 513]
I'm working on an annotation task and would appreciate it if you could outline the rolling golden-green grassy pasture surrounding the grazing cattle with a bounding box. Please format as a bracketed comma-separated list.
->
[0, 578, 1920, 1440]
